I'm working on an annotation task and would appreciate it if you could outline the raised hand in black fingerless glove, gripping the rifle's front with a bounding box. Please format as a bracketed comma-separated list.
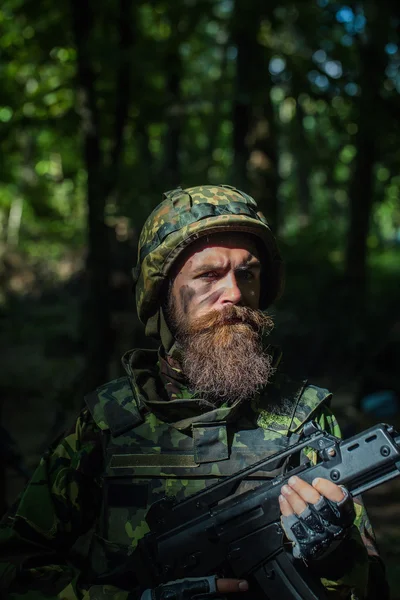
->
[279, 476, 355, 559]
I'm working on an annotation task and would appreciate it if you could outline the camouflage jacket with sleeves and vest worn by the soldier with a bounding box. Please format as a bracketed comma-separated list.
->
[0, 351, 386, 600]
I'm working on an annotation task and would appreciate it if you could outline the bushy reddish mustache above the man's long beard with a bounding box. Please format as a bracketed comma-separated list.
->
[182, 305, 274, 335]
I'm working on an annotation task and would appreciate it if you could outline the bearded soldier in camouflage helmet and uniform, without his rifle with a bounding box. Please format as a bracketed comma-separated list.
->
[0, 186, 387, 600]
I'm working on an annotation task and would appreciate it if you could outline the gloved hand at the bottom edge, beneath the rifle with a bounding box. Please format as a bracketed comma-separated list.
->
[140, 575, 249, 600]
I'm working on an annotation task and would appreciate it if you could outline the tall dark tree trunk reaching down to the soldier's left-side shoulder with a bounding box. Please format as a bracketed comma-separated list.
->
[71, 0, 111, 391]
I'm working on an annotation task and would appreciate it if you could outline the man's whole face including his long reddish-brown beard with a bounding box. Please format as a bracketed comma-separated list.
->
[167, 233, 273, 407]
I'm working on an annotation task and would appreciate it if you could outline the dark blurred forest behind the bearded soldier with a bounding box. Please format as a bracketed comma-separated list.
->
[0, 0, 400, 598]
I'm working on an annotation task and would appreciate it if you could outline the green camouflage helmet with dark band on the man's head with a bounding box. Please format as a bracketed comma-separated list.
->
[132, 185, 283, 324]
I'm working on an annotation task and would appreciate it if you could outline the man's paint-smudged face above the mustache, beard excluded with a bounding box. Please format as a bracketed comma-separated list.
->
[171, 232, 261, 321]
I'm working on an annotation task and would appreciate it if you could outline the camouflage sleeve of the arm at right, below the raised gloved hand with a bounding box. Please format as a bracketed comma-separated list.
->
[307, 407, 389, 600]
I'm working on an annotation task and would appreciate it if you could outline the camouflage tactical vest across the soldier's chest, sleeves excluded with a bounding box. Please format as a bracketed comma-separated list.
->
[86, 370, 330, 589]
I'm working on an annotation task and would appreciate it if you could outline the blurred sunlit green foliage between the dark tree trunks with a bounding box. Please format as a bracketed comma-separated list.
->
[0, 0, 400, 258]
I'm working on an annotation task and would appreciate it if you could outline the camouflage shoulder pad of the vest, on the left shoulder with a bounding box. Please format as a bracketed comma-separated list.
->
[85, 376, 143, 437]
